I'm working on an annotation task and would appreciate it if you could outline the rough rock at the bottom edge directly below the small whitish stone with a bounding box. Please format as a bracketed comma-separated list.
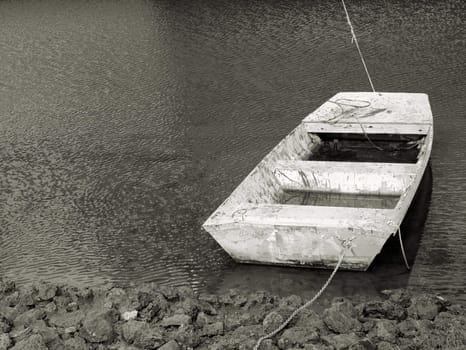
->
[121, 320, 164, 349]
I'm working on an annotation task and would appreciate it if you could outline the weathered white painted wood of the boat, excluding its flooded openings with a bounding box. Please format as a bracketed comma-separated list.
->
[203, 93, 433, 270]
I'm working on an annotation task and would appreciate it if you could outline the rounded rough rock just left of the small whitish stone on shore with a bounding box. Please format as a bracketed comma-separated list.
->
[79, 311, 114, 343]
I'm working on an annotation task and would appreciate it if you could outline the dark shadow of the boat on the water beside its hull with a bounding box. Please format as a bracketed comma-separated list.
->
[207, 164, 432, 298]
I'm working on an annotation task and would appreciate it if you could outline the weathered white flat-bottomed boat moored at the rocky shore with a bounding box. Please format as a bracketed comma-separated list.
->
[203, 92, 433, 271]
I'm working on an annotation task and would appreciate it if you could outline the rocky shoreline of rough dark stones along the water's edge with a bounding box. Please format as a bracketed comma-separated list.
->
[0, 279, 466, 350]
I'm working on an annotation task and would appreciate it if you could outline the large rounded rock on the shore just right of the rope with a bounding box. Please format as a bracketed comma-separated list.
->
[323, 300, 361, 334]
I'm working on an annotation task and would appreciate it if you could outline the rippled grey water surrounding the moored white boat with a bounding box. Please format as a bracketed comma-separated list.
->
[0, 0, 466, 301]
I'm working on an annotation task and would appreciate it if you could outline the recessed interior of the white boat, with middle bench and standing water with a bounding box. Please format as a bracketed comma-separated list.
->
[215, 124, 426, 221]
